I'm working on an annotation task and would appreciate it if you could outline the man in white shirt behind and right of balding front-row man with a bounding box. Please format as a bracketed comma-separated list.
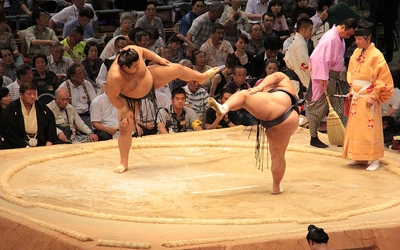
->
[59, 63, 96, 127]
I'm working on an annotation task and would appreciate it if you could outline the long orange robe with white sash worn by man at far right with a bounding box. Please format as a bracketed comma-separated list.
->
[342, 43, 394, 161]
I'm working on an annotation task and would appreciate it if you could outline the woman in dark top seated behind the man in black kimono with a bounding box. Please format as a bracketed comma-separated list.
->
[32, 53, 60, 104]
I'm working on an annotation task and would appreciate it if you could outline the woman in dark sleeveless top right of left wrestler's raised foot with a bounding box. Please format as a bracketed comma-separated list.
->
[210, 54, 240, 97]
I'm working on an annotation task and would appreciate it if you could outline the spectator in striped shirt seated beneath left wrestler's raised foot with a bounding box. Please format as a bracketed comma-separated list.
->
[183, 77, 210, 121]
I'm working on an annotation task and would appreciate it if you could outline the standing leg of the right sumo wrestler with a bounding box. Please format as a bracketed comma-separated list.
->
[266, 111, 299, 194]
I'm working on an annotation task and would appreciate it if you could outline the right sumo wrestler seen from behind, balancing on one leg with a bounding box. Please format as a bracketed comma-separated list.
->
[208, 72, 299, 194]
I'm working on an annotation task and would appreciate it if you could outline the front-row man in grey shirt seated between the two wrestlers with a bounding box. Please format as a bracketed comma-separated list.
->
[157, 88, 202, 134]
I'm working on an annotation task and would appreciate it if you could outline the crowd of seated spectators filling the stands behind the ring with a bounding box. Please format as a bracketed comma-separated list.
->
[0, 0, 400, 148]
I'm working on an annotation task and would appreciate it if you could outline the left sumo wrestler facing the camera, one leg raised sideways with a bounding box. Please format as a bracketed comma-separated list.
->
[106, 45, 219, 173]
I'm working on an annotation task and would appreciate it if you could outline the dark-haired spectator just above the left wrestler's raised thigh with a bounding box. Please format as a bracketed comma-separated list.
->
[168, 33, 195, 63]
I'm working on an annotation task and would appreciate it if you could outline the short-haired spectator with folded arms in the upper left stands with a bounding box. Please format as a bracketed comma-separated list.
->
[25, 9, 58, 56]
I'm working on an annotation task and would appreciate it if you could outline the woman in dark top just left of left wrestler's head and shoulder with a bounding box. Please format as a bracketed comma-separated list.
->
[82, 41, 103, 86]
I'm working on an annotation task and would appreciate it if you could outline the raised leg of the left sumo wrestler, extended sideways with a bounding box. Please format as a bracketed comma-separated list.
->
[148, 63, 220, 89]
